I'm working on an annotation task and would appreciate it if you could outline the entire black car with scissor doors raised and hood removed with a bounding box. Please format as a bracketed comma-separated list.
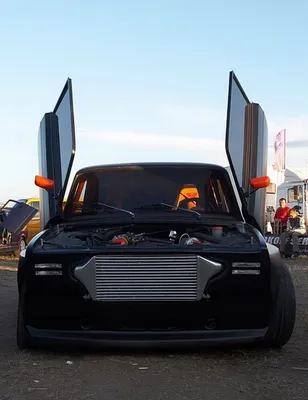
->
[17, 72, 296, 349]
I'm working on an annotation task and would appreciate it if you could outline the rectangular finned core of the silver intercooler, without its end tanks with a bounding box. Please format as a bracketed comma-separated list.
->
[95, 255, 198, 301]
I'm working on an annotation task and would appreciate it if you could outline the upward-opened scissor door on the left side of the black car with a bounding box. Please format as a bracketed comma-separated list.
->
[38, 78, 76, 229]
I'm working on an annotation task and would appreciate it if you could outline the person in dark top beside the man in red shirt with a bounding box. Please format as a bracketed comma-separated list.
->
[280, 208, 306, 256]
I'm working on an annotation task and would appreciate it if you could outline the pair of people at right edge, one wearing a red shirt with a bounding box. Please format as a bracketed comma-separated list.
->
[274, 198, 306, 257]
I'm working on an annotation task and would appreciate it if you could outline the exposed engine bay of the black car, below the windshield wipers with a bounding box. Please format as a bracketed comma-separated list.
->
[35, 224, 259, 248]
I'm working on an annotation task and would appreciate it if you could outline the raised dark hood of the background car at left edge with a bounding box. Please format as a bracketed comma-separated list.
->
[0, 199, 37, 236]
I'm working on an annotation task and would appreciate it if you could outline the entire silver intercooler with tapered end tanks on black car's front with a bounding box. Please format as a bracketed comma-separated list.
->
[75, 254, 222, 302]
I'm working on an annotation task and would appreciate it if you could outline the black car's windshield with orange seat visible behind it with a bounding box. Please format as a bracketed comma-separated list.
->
[64, 165, 239, 219]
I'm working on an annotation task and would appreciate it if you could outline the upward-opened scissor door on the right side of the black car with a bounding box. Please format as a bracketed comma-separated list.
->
[225, 71, 268, 230]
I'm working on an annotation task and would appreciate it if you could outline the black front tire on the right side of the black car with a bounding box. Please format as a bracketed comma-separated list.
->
[265, 263, 296, 348]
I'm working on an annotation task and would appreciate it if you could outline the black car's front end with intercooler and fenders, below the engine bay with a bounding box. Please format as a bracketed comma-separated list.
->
[18, 214, 273, 346]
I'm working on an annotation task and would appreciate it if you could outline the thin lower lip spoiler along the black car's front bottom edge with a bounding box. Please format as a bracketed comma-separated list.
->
[26, 326, 267, 348]
